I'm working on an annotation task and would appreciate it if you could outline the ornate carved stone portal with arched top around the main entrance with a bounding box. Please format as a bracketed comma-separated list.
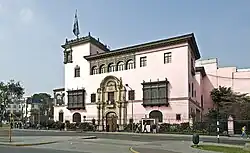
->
[97, 76, 127, 131]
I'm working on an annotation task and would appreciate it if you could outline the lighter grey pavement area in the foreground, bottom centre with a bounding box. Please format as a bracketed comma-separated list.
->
[10, 136, 217, 153]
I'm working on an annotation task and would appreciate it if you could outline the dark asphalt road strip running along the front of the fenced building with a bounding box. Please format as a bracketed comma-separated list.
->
[13, 130, 249, 145]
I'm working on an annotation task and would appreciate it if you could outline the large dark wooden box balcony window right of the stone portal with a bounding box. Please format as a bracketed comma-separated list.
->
[142, 80, 168, 106]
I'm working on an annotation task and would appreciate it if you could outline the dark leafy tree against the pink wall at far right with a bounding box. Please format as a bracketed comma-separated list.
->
[207, 86, 250, 119]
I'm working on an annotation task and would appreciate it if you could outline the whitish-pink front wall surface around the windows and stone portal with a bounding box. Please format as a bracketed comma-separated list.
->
[54, 40, 193, 122]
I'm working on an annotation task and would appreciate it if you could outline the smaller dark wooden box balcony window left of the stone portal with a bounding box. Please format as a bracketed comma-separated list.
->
[67, 90, 85, 109]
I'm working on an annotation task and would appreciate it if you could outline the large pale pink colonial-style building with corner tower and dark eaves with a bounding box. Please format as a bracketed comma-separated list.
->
[54, 34, 249, 131]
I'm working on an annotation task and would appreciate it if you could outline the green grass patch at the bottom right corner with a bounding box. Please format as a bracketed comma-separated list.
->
[192, 145, 250, 153]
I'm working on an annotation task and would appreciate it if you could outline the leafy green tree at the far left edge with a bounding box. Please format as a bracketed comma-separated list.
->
[0, 80, 24, 123]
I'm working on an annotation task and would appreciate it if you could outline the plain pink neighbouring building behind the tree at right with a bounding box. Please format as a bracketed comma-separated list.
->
[195, 58, 250, 114]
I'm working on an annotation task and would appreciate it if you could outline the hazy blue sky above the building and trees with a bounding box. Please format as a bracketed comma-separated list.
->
[0, 0, 250, 96]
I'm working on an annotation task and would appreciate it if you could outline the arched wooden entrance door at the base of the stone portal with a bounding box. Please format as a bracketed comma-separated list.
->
[106, 112, 117, 132]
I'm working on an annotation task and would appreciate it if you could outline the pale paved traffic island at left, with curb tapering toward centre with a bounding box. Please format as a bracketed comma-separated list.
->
[0, 136, 96, 146]
